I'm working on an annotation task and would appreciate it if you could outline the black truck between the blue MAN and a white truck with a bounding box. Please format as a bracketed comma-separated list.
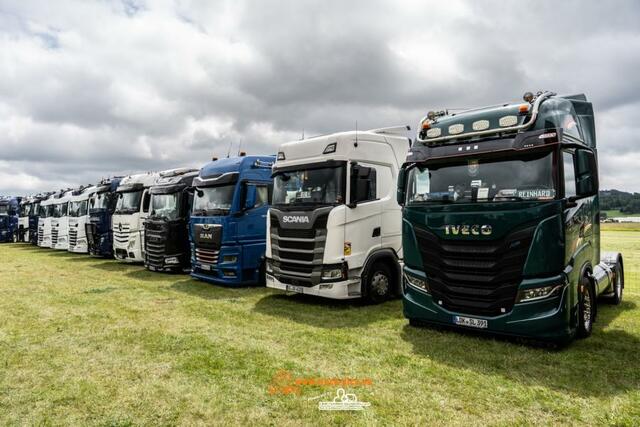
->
[144, 169, 198, 272]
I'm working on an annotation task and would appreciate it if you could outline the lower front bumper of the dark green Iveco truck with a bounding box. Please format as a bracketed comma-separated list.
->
[403, 279, 575, 342]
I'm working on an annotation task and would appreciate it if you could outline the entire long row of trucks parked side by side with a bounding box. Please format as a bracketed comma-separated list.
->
[0, 92, 624, 342]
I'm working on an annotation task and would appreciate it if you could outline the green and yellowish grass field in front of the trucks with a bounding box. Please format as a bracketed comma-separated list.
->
[0, 224, 640, 426]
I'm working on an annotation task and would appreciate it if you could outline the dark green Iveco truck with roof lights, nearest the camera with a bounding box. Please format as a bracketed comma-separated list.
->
[398, 92, 624, 343]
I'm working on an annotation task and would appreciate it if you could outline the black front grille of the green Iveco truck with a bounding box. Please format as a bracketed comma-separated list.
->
[414, 225, 536, 316]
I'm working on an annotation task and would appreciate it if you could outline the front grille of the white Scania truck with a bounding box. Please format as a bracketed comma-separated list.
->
[270, 213, 329, 286]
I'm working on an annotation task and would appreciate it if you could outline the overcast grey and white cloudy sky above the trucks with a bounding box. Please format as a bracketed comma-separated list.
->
[0, 0, 640, 194]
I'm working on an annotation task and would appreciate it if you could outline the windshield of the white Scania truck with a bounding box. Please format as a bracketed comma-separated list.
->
[273, 166, 345, 206]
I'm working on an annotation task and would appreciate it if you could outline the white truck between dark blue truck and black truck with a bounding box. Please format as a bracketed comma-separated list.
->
[111, 172, 160, 262]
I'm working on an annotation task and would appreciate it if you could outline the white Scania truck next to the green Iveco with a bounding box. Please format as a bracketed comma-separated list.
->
[265, 126, 411, 303]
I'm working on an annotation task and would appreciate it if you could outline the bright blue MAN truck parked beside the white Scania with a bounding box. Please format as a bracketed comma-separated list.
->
[190, 155, 275, 286]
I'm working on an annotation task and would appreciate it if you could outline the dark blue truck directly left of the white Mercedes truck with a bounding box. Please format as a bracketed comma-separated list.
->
[85, 177, 121, 258]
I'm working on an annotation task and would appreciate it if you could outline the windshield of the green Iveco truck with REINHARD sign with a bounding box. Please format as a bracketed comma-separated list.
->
[407, 151, 557, 204]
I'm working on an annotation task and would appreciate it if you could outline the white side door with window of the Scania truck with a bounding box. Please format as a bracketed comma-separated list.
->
[345, 162, 382, 269]
